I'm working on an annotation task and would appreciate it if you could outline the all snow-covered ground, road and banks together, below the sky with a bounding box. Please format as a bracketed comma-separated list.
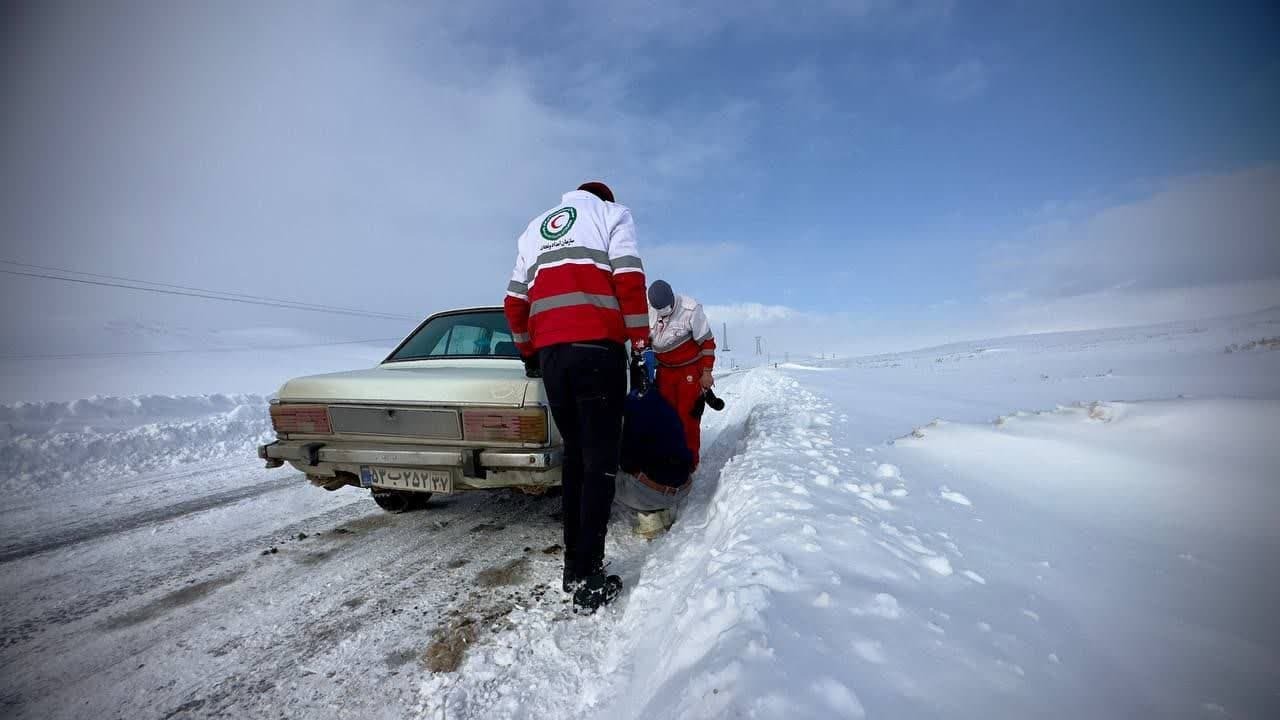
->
[0, 304, 1280, 719]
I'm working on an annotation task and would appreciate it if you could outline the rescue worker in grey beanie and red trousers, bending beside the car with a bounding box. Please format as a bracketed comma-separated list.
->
[649, 281, 716, 469]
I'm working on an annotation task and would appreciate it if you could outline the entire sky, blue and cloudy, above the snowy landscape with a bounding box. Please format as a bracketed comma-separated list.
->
[0, 0, 1280, 368]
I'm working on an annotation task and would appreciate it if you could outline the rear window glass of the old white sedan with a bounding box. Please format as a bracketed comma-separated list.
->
[387, 310, 520, 363]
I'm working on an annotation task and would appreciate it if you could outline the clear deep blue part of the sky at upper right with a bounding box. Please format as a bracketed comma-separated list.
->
[498, 3, 1280, 310]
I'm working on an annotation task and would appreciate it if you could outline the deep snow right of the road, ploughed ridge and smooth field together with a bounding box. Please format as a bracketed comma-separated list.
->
[421, 347, 1280, 719]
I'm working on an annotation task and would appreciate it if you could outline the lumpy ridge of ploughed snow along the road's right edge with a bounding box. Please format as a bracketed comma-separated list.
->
[599, 370, 951, 717]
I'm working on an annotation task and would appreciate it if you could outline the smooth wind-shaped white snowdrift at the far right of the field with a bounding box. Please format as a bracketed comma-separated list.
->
[895, 398, 1280, 539]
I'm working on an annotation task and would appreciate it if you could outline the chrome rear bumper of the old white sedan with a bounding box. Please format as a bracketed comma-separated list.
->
[257, 441, 563, 488]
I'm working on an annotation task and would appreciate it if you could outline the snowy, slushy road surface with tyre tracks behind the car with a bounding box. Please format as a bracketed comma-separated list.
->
[0, 450, 558, 717]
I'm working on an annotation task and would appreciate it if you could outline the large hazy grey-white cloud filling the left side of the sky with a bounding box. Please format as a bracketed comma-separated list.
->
[0, 3, 750, 353]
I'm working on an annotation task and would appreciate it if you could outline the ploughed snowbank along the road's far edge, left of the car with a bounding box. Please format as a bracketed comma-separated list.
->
[0, 395, 271, 492]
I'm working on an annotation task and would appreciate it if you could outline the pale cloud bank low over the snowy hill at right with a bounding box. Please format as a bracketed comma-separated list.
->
[709, 162, 1280, 355]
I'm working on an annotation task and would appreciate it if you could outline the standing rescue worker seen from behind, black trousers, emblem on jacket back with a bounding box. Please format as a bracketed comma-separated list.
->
[504, 182, 649, 611]
